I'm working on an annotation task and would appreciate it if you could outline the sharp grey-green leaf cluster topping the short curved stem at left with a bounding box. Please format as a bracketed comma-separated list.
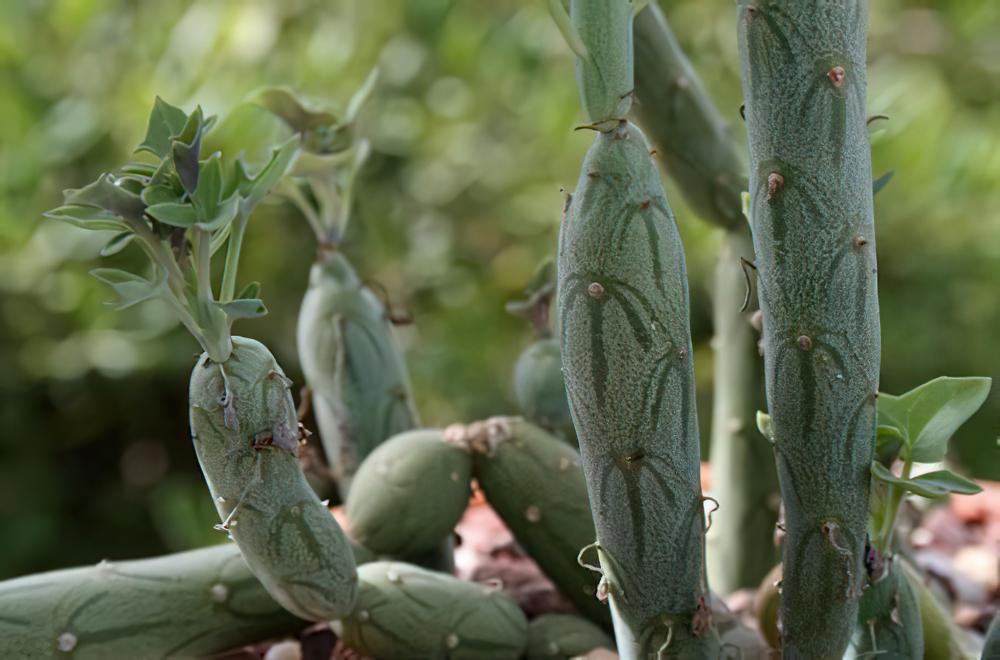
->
[46, 98, 300, 358]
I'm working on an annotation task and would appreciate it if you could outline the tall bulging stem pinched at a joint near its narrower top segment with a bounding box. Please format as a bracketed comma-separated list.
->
[550, 0, 719, 658]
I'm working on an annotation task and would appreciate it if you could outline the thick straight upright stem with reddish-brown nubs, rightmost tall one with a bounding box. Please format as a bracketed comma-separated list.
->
[738, 0, 879, 660]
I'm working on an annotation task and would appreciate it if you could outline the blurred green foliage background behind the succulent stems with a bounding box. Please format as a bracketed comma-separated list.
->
[0, 0, 1000, 578]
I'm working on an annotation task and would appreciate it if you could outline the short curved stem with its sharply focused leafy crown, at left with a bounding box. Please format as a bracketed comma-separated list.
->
[49, 99, 357, 621]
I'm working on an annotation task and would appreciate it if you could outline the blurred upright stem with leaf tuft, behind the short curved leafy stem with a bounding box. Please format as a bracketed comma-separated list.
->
[255, 76, 420, 499]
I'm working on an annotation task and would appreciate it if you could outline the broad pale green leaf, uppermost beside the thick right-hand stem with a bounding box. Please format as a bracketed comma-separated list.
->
[878, 376, 992, 463]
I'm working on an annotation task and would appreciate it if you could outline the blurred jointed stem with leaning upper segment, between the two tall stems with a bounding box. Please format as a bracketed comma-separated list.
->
[633, 2, 778, 594]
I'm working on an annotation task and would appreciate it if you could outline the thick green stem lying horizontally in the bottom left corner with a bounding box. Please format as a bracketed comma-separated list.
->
[0, 543, 308, 660]
